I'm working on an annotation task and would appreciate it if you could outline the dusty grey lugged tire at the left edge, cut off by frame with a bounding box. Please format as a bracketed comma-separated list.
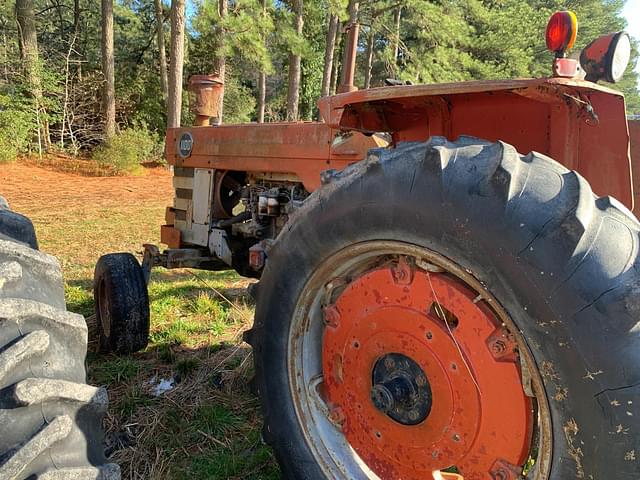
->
[0, 197, 120, 480]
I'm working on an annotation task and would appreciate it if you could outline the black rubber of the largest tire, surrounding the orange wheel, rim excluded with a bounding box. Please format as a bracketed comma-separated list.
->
[246, 137, 640, 480]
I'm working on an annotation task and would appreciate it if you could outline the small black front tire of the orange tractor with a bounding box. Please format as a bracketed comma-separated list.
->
[93, 253, 150, 354]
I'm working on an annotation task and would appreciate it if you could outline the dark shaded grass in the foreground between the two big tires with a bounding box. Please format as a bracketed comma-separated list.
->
[89, 343, 280, 480]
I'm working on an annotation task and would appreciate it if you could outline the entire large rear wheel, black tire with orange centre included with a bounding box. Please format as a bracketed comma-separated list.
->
[245, 137, 640, 480]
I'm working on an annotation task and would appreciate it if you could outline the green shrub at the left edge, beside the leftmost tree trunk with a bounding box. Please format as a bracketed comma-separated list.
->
[0, 93, 35, 163]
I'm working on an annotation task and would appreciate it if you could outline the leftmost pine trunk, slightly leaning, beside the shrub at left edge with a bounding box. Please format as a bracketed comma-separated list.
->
[16, 0, 51, 149]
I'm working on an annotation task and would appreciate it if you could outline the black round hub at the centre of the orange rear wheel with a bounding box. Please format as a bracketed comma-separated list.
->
[371, 353, 431, 425]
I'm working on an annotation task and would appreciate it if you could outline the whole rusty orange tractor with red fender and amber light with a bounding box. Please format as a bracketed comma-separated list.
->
[95, 12, 640, 480]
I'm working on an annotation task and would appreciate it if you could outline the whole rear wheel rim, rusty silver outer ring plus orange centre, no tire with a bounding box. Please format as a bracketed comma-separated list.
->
[288, 241, 551, 480]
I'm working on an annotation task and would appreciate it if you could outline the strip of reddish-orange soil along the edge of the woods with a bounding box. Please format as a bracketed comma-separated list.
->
[0, 162, 173, 213]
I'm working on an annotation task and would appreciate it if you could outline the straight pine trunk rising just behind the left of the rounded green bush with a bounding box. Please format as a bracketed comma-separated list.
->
[102, 0, 116, 140]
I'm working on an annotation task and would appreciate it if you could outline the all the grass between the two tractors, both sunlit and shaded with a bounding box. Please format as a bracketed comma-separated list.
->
[4, 166, 280, 480]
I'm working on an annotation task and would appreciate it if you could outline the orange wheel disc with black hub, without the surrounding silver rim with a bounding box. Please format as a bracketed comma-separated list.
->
[322, 257, 534, 480]
